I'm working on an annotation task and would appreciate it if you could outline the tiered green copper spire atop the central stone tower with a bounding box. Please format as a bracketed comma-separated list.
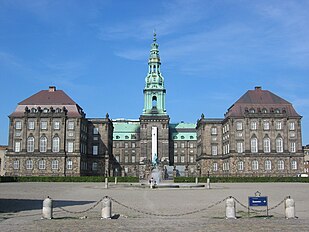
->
[143, 33, 166, 115]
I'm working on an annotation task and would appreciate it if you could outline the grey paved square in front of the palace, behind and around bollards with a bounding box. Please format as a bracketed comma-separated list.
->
[0, 183, 309, 232]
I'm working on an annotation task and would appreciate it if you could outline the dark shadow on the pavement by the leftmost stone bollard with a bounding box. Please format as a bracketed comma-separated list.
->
[0, 198, 95, 213]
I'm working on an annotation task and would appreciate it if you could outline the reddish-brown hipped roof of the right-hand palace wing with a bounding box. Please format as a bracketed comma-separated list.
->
[225, 87, 301, 117]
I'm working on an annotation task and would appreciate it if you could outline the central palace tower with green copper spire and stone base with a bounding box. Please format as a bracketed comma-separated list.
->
[140, 33, 170, 166]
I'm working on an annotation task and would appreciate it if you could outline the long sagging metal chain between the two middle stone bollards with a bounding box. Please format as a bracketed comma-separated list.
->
[109, 197, 229, 217]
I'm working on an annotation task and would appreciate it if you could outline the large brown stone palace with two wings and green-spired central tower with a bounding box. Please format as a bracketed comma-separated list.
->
[5, 35, 304, 179]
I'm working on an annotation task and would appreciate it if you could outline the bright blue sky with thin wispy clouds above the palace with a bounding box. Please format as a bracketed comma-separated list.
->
[0, 0, 309, 144]
